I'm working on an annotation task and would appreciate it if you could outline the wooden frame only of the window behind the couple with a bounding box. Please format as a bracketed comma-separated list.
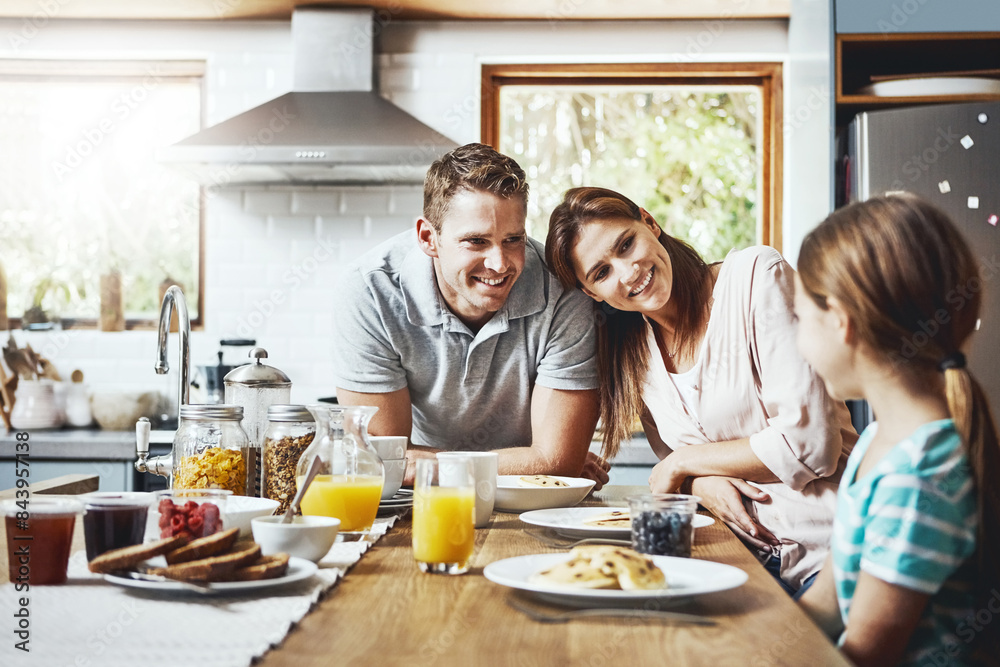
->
[480, 62, 782, 252]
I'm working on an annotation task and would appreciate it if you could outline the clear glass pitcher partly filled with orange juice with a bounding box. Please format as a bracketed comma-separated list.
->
[295, 405, 385, 533]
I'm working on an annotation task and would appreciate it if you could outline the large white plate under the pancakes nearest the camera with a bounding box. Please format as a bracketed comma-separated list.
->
[483, 553, 747, 607]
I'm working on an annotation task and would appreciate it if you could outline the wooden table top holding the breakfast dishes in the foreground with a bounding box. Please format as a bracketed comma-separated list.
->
[0, 487, 848, 667]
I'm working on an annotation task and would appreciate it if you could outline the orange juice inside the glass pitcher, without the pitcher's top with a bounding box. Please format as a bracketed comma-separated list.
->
[297, 475, 382, 533]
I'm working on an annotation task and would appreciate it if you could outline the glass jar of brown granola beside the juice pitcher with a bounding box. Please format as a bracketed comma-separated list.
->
[261, 405, 316, 514]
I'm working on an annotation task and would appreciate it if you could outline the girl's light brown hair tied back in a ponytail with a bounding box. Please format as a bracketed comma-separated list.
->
[798, 195, 1000, 656]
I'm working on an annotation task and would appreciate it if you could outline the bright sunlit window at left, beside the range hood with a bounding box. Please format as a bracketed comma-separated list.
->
[0, 61, 204, 328]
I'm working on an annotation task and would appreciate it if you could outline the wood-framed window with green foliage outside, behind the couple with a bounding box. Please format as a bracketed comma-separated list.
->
[482, 63, 781, 261]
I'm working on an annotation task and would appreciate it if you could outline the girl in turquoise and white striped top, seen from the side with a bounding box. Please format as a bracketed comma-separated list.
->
[795, 195, 1000, 665]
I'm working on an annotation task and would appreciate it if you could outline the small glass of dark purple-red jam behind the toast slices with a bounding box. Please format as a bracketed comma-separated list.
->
[80, 492, 153, 561]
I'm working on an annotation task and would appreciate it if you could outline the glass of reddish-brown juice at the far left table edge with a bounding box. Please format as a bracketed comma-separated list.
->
[0, 496, 83, 586]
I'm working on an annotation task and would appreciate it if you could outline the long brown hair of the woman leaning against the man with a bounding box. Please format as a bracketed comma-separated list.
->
[545, 188, 709, 460]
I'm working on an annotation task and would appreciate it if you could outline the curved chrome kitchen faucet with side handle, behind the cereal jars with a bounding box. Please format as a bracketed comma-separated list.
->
[135, 285, 191, 477]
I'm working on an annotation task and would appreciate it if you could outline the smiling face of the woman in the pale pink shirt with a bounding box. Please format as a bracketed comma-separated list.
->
[570, 211, 673, 314]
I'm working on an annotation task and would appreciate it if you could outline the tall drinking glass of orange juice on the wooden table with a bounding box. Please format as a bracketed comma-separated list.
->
[413, 456, 476, 574]
